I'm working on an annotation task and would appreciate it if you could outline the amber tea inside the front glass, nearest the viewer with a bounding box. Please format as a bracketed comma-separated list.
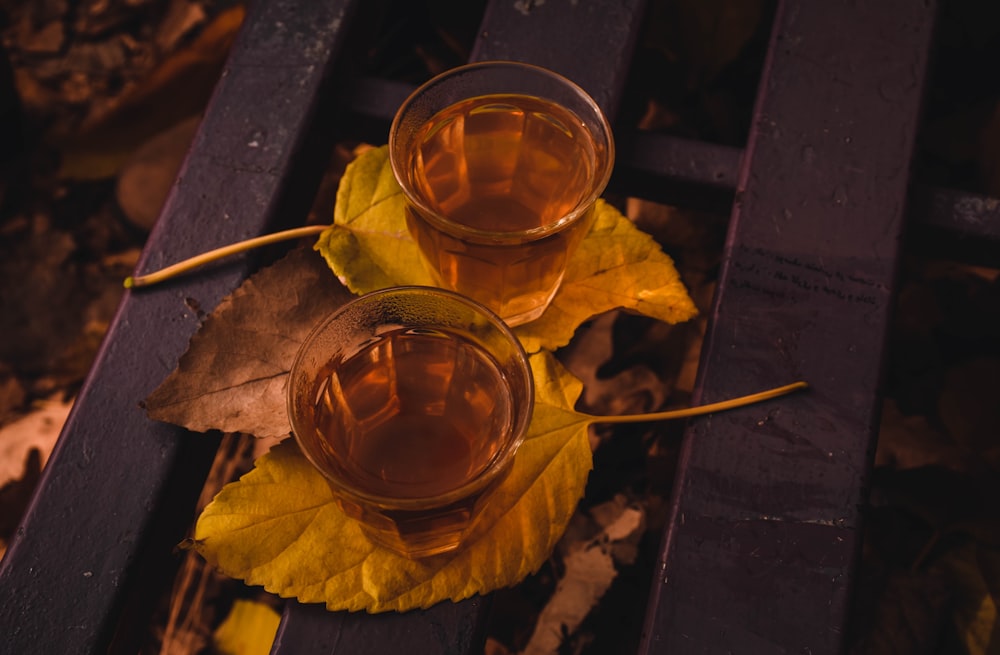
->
[315, 330, 513, 498]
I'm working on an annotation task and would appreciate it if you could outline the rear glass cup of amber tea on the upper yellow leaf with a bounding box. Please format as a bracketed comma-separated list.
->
[389, 61, 614, 325]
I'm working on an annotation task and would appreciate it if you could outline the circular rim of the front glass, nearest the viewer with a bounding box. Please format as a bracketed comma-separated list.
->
[285, 285, 535, 510]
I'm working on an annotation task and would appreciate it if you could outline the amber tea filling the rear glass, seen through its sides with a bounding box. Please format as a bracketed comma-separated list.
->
[407, 95, 602, 325]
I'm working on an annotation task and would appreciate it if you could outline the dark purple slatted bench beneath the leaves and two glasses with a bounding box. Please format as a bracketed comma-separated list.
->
[0, 0, 998, 655]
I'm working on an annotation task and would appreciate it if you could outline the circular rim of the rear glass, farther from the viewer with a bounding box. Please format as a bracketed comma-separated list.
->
[388, 59, 615, 244]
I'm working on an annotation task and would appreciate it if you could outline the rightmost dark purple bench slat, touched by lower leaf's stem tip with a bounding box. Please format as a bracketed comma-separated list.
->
[642, 0, 934, 654]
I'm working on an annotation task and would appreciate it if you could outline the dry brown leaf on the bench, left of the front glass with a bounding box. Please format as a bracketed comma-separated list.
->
[146, 248, 351, 438]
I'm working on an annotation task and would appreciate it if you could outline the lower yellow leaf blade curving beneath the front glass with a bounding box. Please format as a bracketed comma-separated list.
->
[194, 352, 593, 612]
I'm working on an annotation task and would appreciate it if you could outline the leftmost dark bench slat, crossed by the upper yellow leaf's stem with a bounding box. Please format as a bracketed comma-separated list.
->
[0, 0, 370, 653]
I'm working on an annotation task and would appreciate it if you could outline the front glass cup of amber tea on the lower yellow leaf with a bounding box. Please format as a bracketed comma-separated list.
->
[288, 287, 534, 558]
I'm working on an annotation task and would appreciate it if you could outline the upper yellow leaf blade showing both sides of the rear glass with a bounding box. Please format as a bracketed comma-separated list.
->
[316, 146, 697, 352]
